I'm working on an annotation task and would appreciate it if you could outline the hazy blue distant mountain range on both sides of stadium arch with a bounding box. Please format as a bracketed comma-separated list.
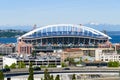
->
[0, 23, 120, 31]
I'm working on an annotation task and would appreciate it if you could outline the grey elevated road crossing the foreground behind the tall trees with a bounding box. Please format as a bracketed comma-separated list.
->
[4, 68, 120, 77]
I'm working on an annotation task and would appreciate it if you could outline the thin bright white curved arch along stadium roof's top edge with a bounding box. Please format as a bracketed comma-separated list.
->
[18, 24, 111, 39]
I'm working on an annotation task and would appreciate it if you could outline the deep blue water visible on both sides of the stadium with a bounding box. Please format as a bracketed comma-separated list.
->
[0, 31, 120, 43]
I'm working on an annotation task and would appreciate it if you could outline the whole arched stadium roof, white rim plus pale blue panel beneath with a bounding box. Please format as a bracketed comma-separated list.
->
[18, 24, 111, 39]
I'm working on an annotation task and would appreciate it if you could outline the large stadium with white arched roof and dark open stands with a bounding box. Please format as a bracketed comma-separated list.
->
[18, 24, 111, 51]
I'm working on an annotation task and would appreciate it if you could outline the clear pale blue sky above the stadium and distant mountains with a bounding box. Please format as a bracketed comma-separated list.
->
[0, 0, 120, 25]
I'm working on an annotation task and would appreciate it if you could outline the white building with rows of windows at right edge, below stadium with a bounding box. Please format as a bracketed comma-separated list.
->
[95, 50, 120, 62]
